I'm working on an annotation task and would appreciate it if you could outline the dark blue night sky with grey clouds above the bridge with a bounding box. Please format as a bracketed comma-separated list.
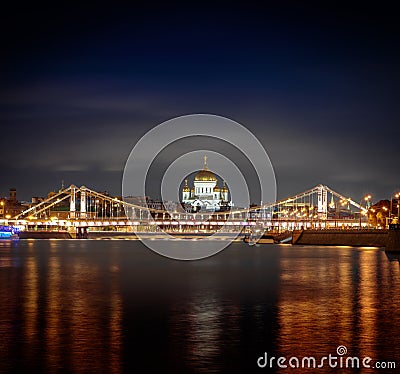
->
[0, 2, 400, 200]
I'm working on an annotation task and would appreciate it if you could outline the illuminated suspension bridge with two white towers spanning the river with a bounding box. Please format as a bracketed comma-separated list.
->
[3, 184, 368, 232]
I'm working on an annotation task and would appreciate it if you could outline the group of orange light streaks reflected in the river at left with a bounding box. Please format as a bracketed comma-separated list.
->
[0, 241, 123, 373]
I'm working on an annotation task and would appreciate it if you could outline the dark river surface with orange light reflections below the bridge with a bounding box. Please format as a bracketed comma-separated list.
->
[0, 240, 400, 373]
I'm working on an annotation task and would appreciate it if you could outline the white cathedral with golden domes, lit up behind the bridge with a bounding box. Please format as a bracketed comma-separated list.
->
[182, 156, 232, 212]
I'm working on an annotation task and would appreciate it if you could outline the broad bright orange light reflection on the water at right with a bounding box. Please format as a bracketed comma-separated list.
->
[278, 248, 400, 372]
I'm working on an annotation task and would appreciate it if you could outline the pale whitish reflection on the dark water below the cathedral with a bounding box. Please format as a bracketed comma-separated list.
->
[168, 290, 244, 373]
